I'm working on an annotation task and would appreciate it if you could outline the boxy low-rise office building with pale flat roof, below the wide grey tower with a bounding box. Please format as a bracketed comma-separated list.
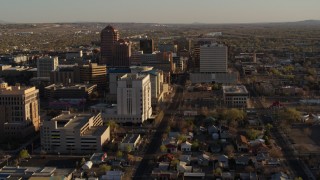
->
[222, 85, 249, 108]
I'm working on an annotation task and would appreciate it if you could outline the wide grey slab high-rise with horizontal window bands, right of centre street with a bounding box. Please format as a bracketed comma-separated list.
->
[200, 44, 228, 73]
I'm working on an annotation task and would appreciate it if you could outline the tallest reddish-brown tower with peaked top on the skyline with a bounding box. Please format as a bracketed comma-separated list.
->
[99, 25, 119, 65]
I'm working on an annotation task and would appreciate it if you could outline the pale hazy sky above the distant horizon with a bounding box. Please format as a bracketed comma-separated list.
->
[0, 0, 320, 23]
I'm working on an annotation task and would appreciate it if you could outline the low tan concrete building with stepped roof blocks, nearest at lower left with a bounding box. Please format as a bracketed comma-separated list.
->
[41, 111, 110, 154]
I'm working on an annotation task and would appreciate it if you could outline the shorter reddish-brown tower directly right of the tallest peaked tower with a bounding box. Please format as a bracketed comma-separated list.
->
[112, 39, 131, 67]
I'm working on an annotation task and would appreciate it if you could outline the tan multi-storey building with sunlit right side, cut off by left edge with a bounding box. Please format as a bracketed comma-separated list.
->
[0, 82, 40, 138]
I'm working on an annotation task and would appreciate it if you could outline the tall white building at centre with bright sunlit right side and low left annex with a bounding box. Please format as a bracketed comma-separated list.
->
[91, 73, 152, 124]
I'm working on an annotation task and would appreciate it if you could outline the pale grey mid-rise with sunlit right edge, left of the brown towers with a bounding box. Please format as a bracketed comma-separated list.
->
[37, 56, 59, 78]
